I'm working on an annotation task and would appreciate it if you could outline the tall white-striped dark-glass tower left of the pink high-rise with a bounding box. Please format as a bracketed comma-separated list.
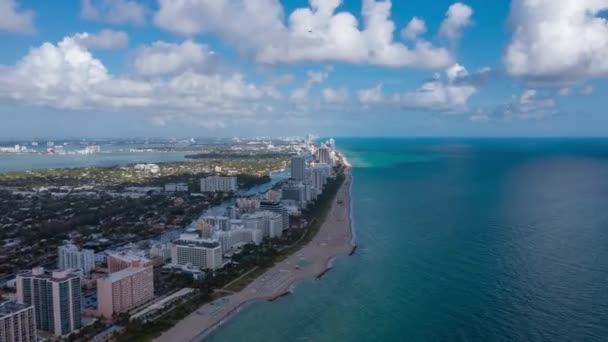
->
[17, 267, 82, 336]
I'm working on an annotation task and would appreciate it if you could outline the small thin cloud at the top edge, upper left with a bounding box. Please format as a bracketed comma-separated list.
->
[80, 0, 147, 24]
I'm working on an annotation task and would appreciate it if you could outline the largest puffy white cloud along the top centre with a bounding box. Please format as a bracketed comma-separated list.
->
[154, 0, 456, 69]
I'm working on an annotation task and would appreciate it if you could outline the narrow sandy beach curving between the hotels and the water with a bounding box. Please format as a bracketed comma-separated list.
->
[155, 162, 355, 342]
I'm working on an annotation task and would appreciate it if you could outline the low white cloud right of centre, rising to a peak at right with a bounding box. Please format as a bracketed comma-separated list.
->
[358, 64, 477, 112]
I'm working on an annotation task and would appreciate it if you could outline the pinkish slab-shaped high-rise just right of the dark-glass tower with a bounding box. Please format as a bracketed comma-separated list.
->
[97, 261, 154, 319]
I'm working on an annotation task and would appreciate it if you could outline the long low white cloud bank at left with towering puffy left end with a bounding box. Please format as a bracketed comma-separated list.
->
[0, 36, 278, 121]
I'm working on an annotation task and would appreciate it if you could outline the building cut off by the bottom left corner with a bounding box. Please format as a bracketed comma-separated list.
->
[0, 301, 37, 342]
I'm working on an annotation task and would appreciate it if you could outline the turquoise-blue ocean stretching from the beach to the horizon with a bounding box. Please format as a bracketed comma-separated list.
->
[208, 139, 608, 342]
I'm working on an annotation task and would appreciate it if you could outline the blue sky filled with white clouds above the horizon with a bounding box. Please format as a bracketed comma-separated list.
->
[0, 0, 608, 138]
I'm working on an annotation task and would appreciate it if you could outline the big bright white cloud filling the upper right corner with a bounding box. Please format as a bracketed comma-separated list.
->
[504, 0, 608, 84]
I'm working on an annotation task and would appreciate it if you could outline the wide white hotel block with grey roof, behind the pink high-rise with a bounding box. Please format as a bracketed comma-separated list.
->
[171, 230, 222, 270]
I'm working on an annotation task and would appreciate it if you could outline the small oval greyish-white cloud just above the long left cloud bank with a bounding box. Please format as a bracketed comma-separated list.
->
[133, 40, 217, 76]
